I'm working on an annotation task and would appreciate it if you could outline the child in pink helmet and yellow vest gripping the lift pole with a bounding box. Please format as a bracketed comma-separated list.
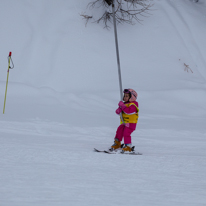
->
[110, 89, 139, 152]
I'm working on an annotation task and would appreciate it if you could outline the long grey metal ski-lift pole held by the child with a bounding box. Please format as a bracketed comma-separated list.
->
[112, 0, 124, 124]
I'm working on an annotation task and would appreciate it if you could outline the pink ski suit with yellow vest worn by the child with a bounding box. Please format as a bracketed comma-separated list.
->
[115, 101, 139, 144]
